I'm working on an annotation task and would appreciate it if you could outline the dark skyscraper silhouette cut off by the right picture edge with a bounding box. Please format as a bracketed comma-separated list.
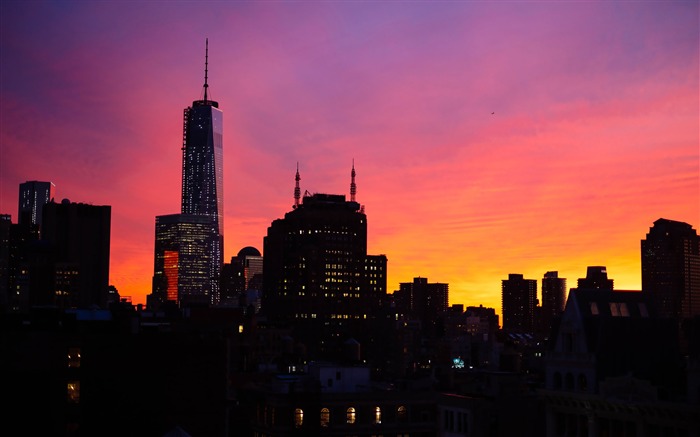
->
[641, 218, 700, 319]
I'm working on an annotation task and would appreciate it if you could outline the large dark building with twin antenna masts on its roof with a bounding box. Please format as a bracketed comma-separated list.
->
[262, 166, 387, 362]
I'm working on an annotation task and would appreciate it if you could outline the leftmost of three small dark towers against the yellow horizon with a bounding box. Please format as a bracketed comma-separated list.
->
[501, 273, 537, 333]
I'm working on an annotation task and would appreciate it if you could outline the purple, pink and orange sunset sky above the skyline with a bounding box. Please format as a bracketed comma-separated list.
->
[0, 0, 700, 313]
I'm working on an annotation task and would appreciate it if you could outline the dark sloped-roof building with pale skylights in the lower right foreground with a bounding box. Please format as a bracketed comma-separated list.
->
[540, 289, 700, 437]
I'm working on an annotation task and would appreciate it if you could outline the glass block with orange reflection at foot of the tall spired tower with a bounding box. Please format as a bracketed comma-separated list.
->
[153, 214, 219, 305]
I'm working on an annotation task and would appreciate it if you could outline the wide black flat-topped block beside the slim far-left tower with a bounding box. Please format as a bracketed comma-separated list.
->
[41, 199, 112, 308]
